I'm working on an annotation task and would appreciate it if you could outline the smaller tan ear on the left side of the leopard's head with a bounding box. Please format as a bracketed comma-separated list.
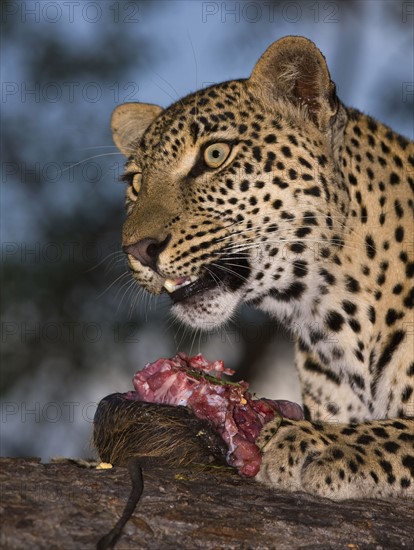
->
[111, 103, 162, 157]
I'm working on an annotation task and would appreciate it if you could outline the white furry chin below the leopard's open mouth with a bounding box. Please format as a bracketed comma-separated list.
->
[171, 288, 241, 331]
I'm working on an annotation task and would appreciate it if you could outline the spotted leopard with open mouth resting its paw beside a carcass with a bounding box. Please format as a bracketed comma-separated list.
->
[111, 36, 414, 500]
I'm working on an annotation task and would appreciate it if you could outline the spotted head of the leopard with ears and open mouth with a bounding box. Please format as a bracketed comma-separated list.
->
[112, 37, 347, 328]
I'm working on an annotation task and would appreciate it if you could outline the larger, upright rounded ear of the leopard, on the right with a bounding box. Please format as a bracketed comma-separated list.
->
[249, 36, 338, 128]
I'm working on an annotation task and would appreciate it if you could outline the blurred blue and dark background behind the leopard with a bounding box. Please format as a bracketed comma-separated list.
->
[0, 0, 414, 460]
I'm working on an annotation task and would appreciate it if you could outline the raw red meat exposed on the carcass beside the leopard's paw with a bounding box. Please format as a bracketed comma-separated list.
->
[125, 353, 302, 477]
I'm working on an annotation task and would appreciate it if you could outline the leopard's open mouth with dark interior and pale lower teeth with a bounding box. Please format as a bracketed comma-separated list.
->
[163, 258, 250, 304]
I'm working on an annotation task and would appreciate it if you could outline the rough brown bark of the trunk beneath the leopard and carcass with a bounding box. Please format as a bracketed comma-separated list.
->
[0, 458, 414, 550]
